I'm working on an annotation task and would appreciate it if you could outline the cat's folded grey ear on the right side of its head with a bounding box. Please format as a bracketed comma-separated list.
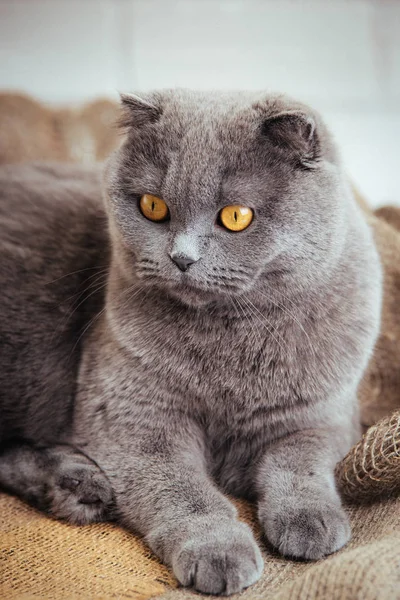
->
[262, 111, 321, 168]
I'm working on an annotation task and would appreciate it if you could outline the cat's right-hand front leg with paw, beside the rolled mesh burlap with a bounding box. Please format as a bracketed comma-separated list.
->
[257, 430, 351, 559]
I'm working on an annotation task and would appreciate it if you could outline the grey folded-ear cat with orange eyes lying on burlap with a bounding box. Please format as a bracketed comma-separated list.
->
[0, 90, 381, 594]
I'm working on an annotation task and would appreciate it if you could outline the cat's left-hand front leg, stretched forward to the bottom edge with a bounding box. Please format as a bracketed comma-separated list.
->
[92, 426, 263, 595]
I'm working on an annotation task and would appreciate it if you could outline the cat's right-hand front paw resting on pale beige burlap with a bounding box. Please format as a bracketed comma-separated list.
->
[260, 504, 351, 560]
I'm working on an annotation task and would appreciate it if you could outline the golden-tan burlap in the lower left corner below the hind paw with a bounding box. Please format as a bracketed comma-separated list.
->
[0, 494, 175, 600]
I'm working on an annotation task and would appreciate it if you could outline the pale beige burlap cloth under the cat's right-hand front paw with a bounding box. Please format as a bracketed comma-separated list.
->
[156, 498, 400, 600]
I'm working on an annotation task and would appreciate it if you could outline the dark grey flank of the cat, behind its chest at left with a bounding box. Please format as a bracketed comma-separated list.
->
[0, 164, 109, 442]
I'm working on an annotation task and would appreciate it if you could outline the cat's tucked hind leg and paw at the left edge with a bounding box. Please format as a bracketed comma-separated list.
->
[0, 443, 112, 525]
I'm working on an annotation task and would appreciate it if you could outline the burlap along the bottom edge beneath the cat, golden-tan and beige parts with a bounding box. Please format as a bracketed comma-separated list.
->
[0, 495, 400, 600]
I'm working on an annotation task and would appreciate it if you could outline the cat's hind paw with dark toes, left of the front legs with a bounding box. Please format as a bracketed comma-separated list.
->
[47, 455, 113, 525]
